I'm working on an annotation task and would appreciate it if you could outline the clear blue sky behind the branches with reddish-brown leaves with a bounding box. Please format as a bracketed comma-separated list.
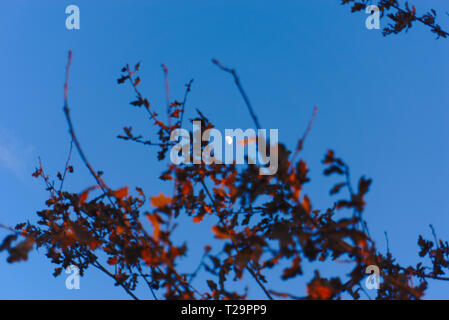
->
[0, 0, 449, 299]
